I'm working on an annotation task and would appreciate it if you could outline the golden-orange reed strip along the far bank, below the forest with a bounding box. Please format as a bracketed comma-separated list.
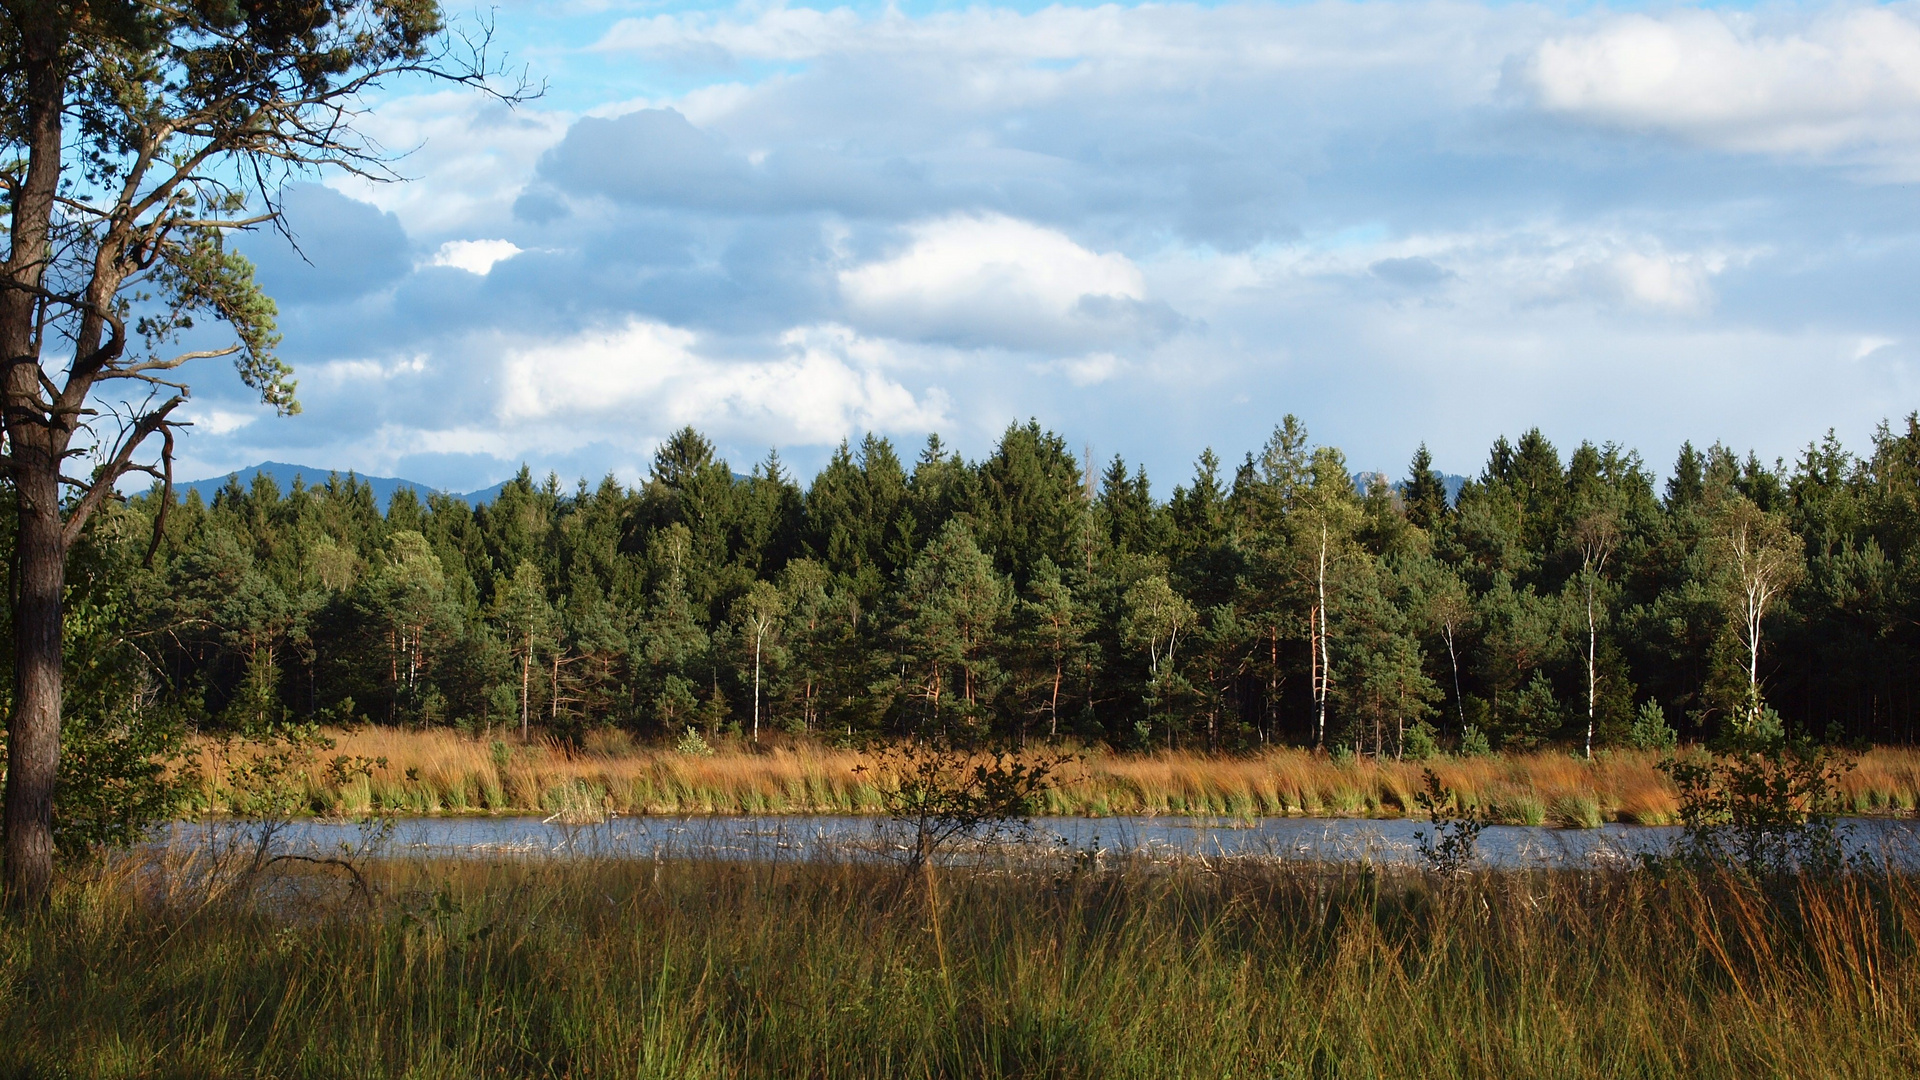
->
[180, 726, 1920, 828]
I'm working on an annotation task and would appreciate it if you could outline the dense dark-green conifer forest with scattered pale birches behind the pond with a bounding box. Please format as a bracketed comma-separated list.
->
[30, 417, 1920, 753]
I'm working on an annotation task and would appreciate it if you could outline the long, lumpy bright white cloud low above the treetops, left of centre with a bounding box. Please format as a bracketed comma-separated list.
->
[497, 319, 945, 444]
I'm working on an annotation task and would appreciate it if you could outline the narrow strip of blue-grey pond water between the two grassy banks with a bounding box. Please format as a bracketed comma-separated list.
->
[167, 815, 1920, 869]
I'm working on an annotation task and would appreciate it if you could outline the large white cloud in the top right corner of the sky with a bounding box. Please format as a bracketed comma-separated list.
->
[1519, 6, 1920, 154]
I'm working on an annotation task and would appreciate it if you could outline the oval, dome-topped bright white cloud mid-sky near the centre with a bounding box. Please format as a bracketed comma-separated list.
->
[839, 213, 1146, 348]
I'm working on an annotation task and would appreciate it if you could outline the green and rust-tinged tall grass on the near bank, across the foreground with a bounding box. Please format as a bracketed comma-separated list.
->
[0, 861, 1920, 1080]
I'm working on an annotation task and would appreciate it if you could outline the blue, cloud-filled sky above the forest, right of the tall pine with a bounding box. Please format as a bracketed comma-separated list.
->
[168, 0, 1920, 494]
